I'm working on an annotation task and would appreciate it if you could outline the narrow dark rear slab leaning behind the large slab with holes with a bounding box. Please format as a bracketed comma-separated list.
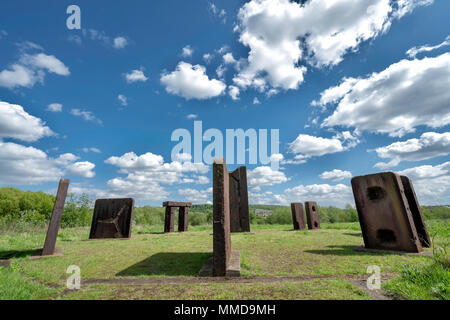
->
[400, 176, 431, 248]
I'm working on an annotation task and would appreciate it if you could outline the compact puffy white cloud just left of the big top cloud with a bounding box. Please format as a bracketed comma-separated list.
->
[161, 61, 226, 100]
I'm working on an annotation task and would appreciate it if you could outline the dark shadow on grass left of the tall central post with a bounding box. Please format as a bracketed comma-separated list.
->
[116, 252, 211, 276]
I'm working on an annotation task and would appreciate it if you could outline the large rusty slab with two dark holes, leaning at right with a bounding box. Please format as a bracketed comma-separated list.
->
[352, 172, 422, 252]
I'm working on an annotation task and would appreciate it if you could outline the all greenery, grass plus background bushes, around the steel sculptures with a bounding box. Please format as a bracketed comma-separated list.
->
[0, 188, 450, 299]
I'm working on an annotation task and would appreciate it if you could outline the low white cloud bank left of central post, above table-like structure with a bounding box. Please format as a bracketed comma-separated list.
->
[105, 152, 209, 201]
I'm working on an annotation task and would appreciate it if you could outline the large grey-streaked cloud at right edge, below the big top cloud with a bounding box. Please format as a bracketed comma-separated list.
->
[317, 53, 450, 137]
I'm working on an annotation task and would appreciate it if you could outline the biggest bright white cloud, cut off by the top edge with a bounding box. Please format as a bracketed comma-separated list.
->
[233, 0, 430, 90]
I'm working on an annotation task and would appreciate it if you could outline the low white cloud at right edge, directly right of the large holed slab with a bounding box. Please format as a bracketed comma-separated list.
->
[398, 162, 450, 205]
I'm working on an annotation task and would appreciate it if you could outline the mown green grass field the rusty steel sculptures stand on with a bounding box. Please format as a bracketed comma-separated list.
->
[0, 220, 450, 299]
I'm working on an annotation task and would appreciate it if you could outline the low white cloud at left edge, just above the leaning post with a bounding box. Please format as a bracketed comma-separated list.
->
[0, 141, 95, 185]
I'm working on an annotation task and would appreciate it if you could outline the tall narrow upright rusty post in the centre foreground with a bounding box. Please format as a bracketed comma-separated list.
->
[213, 158, 231, 276]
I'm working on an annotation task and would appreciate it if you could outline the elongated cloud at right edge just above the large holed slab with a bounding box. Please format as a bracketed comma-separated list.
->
[375, 132, 450, 169]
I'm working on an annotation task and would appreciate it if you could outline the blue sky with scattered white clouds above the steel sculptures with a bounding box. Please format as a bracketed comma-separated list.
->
[0, 0, 450, 207]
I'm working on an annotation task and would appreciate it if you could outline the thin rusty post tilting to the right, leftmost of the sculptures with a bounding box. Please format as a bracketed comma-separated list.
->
[42, 179, 70, 256]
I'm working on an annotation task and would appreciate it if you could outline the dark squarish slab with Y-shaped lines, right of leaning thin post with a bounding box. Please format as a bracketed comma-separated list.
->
[89, 198, 134, 239]
